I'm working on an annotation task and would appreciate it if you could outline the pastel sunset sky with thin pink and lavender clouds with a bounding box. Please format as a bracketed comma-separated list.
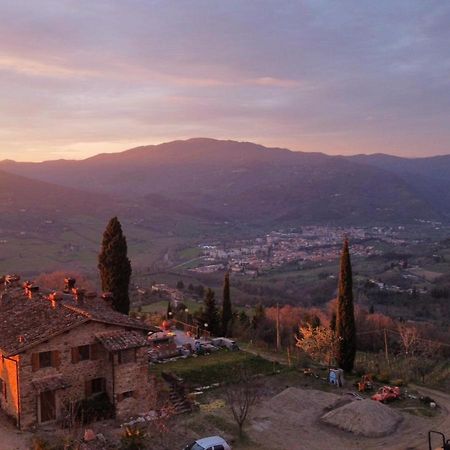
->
[0, 0, 450, 161]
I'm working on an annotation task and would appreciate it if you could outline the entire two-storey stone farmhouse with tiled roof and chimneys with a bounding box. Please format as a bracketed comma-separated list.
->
[0, 277, 160, 430]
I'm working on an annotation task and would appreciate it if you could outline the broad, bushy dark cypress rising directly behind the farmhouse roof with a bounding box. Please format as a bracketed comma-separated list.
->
[98, 217, 131, 314]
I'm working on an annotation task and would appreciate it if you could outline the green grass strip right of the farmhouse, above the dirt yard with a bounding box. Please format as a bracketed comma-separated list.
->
[150, 350, 283, 386]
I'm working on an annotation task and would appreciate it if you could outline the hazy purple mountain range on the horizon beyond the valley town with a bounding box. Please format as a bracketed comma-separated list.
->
[0, 138, 450, 225]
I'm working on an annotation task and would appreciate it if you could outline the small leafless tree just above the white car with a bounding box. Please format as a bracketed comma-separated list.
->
[225, 366, 262, 437]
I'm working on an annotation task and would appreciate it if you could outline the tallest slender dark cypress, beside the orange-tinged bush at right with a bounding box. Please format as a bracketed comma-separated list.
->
[336, 238, 356, 372]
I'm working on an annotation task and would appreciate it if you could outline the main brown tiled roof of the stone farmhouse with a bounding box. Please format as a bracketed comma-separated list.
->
[0, 287, 159, 356]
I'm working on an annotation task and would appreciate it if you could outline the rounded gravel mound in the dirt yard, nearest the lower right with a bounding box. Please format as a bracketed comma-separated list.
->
[321, 399, 402, 437]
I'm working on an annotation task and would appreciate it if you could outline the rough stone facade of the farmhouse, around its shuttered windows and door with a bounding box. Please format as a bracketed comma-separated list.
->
[20, 322, 155, 429]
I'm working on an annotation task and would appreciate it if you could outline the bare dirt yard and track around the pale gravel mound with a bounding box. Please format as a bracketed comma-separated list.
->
[249, 387, 450, 450]
